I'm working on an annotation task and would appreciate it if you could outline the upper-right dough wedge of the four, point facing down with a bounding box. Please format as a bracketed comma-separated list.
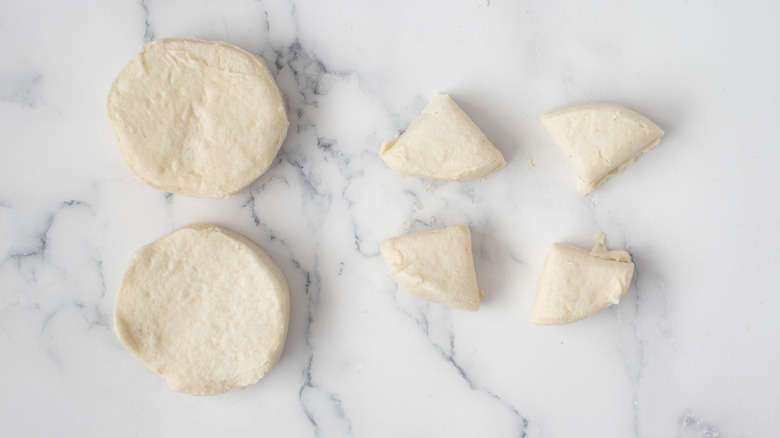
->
[542, 103, 664, 195]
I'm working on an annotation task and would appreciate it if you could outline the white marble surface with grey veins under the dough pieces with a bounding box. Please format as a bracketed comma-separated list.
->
[0, 0, 780, 438]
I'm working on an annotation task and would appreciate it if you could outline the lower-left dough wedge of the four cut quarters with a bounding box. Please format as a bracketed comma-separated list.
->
[381, 225, 482, 311]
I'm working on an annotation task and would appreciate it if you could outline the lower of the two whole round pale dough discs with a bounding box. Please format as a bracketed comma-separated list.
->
[114, 224, 290, 395]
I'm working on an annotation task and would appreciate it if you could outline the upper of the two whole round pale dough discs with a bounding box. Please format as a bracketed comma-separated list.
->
[107, 39, 288, 198]
